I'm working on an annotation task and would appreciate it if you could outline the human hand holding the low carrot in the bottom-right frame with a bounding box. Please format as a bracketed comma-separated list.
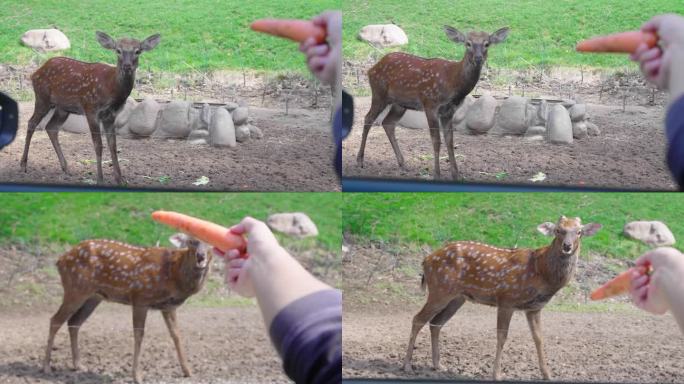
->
[629, 247, 684, 314]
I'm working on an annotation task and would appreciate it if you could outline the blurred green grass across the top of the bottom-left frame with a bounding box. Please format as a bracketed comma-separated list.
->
[0, 192, 342, 254]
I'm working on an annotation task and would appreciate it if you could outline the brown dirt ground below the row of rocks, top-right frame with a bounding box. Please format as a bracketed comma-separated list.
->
[342, 97, 676, 190]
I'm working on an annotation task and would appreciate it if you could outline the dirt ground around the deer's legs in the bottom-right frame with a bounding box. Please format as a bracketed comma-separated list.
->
[342, 243, 684, 383]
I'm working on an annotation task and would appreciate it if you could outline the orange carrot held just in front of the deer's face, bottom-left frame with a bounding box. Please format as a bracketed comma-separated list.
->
[152, 211, 247, 252]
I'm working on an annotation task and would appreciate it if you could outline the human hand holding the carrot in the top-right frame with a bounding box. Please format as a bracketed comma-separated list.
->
[630, 14, 684, 90]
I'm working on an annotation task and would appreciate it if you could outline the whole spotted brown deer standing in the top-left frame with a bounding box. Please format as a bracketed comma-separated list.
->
[20, 32, 160, 185]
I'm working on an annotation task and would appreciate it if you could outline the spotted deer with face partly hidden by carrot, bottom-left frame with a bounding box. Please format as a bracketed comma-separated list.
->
[43, 233, 212, 383]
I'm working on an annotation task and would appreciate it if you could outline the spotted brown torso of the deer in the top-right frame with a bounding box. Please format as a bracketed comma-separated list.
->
[368, 52, 460, 109]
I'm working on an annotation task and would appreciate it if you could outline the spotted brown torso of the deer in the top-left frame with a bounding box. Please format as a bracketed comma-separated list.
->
[31, 57, 118, 114]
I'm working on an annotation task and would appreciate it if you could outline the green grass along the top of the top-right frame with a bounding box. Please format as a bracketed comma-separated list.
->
[342, 0, 684, 69]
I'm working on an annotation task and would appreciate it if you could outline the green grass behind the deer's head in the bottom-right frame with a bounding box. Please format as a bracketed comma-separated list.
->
[342, 193, 684, 259]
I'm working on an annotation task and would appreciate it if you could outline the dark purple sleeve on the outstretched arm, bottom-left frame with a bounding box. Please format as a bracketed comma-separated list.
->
[270, 289, 342, 384]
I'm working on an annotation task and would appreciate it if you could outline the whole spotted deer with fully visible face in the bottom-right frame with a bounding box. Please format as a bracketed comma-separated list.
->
[404, 216, 601, 380]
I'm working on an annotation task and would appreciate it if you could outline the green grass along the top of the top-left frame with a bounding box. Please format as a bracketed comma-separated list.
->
[0, 0, 339, 72]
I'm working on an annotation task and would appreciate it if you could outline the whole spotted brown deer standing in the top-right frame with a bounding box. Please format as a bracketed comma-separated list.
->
[356, 26, 508, 180]
